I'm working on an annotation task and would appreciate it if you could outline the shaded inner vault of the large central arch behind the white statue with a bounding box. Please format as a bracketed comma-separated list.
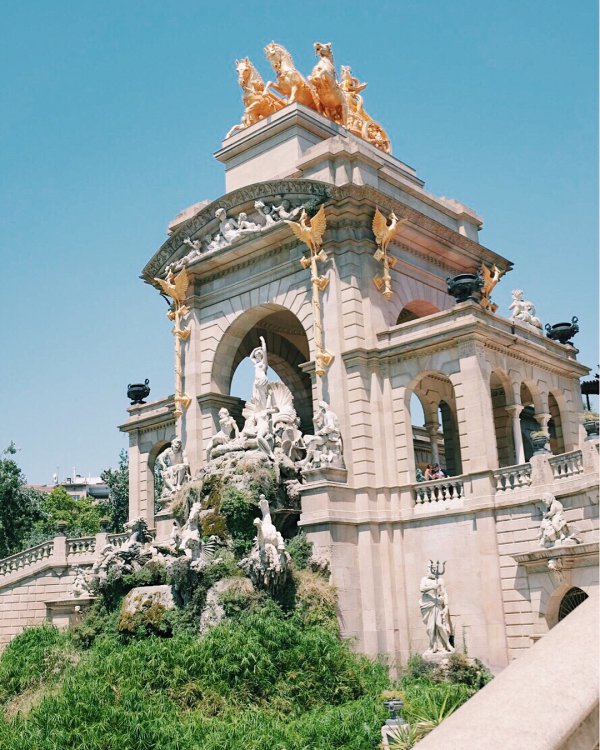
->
[212, 304, 313, 432]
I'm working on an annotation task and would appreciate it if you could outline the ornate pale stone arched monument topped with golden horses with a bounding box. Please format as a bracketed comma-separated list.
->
[0, 42, 598, 666]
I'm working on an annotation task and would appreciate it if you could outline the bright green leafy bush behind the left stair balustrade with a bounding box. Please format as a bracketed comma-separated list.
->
[27, 487, 108, 546]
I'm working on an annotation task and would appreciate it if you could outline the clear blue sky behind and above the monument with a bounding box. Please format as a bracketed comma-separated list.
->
[0, 0, 598, 482]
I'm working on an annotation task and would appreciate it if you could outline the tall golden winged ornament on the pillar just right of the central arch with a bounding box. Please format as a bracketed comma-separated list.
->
[285, 206, 334, 377]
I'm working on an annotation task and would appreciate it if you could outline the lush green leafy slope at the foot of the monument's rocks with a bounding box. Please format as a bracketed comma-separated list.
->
[0, 607, 387, 750]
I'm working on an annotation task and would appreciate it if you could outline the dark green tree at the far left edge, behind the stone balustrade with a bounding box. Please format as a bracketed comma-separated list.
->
[0, 442, 43, 558]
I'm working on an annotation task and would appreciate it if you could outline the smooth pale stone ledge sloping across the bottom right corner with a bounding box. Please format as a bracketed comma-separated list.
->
[419, 598, 599, 750]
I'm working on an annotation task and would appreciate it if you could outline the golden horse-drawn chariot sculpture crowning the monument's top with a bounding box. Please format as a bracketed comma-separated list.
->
[227, 42, 392, 154]
